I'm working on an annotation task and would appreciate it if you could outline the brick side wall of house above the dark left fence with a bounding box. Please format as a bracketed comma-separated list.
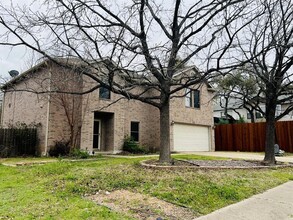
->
[2, 71, 48, 153]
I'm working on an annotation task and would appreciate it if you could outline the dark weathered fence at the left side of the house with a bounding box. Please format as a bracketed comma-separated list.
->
[0, 128, 38, 157]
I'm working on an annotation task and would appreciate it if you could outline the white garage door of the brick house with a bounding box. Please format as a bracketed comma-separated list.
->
[173, 124, 210, 151]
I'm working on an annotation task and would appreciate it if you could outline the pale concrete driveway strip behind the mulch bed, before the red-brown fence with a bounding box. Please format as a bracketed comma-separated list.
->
[185, 151, 293, 163]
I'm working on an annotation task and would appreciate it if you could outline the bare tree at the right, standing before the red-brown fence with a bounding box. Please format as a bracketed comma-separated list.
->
[239, 0, 293, 164]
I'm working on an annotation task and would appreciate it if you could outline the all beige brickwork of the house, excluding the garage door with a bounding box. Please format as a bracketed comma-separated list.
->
[2, 61, 214, 154]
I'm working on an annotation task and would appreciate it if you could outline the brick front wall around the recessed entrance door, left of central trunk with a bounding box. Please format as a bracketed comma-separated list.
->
[81, 75, 159, 151]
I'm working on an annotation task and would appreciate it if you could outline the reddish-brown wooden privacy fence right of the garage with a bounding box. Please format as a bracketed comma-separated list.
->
[215, 121, 293, 153]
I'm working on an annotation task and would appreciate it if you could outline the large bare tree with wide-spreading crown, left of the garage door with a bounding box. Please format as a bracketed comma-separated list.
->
[0, 0, 253, 162]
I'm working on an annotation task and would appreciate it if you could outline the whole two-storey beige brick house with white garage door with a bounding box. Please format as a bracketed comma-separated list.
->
[2, 58, 214, 155]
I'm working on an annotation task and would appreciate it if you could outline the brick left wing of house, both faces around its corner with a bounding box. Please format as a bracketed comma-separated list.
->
[2, 64, 82, 154]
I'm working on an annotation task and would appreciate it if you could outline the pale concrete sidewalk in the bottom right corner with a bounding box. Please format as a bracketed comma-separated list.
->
[196, 181, 293, 220]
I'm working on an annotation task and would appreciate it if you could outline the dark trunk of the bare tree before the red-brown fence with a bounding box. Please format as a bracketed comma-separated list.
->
[264, 100, 276, 165]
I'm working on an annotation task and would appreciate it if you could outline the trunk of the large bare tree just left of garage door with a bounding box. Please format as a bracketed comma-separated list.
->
[159, 99, 171, 163]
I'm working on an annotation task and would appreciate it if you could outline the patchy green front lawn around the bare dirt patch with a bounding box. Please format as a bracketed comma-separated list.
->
[0, 155, 293, 219]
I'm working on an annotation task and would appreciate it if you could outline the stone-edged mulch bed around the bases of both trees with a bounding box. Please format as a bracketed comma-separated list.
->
[141, 159, 293, 169]
